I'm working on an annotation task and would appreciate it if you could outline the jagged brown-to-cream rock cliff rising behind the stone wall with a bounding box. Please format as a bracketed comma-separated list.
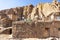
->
[0, 1, 60, 21]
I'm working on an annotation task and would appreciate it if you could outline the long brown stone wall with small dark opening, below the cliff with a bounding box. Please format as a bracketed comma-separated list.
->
[12, 21, 60, 38]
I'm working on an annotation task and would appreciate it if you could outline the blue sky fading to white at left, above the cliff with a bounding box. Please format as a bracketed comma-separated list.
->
[0, 0, 60, 10]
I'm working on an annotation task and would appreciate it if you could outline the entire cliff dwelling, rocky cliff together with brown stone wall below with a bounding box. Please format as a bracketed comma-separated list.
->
[0, 0, 60, 40]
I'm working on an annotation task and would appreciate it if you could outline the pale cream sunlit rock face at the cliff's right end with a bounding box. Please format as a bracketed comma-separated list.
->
[31, 2, 60, 21]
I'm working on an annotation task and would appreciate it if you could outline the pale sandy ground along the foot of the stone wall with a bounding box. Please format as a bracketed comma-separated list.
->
[0, 34, 60, 40]
